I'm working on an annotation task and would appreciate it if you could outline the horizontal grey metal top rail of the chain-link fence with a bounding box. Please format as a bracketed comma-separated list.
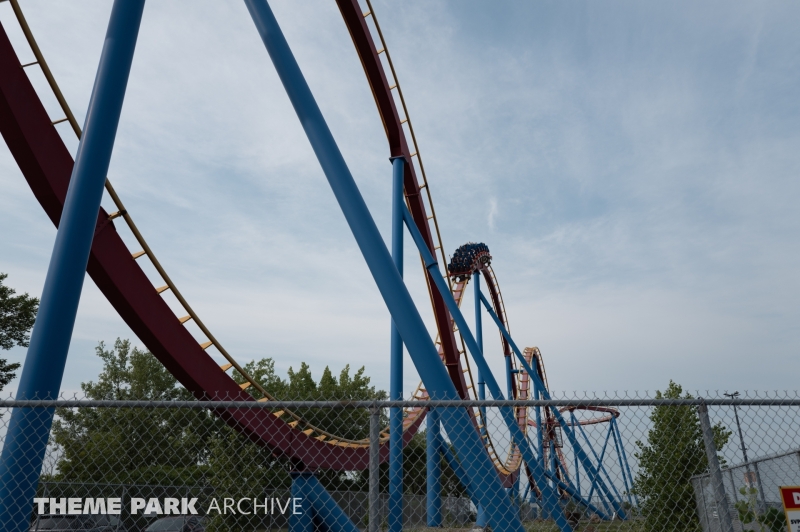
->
[0, 396, 800, 409]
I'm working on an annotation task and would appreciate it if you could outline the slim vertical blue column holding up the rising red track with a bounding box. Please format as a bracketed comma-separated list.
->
[389, 157, 405, 532]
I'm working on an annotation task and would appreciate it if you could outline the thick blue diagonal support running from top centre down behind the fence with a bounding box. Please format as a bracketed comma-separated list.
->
[245, 0, 523, 532]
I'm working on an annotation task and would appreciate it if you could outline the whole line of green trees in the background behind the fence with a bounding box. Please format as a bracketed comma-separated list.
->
[0, 273, 755, 531]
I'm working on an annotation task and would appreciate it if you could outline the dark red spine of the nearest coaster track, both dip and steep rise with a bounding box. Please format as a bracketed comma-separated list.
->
[0, 0, 478, 470]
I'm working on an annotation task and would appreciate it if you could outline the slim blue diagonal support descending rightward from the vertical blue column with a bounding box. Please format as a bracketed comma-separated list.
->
[403, 205, 572, 531]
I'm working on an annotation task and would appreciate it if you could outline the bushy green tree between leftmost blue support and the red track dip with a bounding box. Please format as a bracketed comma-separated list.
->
[53, 339, 222, 484]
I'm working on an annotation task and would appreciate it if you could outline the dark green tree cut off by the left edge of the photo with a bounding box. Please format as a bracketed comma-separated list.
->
[0, 273, 39, 390]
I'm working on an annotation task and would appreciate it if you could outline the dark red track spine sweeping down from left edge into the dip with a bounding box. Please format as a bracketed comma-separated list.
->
[0, 13, 424, 470]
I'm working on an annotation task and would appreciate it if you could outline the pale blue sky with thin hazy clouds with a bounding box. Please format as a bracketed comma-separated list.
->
[0, 0, 800, 400]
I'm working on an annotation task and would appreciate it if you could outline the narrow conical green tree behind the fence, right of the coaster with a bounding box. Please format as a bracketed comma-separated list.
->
[634, 381, 731, 532]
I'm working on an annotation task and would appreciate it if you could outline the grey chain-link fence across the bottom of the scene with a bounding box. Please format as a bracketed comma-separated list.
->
[0, 394, 800, 532]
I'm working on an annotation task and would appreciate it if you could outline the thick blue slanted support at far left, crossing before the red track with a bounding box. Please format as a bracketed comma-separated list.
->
[0, 0, 144, 532]
